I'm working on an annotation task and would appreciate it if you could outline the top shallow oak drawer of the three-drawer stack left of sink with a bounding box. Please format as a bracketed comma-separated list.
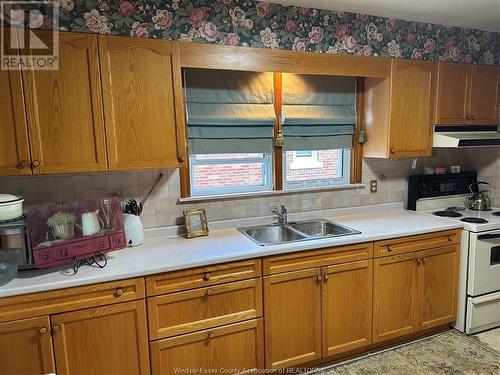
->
[146, 259, 261, 296]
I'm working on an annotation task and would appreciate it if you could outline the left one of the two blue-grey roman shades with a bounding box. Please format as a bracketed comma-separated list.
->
[185, 69, 276, 154]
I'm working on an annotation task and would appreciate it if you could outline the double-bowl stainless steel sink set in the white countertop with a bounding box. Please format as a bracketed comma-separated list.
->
[238, 219, 361, 246]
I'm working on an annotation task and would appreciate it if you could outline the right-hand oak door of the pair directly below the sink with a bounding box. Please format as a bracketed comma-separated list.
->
[322, 260, 373, 357]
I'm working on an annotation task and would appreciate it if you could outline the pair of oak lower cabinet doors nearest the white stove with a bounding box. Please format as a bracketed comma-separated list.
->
[373, 245, 459, 343]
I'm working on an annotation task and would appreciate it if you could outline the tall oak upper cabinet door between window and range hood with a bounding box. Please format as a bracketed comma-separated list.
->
[389, 59, 437, 157]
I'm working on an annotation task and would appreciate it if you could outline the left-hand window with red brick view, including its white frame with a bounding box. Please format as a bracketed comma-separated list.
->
[189, 153, 272, 196]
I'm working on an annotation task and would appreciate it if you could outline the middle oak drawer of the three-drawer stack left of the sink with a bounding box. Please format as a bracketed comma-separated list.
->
[148, 279, 262, 340]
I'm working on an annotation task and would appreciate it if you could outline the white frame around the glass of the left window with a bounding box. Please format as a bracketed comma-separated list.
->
[188, 152, 273, 197]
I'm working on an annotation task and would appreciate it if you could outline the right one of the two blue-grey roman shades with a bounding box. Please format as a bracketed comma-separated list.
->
[282, 73, 356, 151]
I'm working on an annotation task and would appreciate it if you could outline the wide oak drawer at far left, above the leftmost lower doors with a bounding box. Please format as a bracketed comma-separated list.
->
[0, 278, 145, 321]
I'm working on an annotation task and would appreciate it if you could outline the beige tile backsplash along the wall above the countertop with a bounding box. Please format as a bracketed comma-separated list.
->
[0, 148, 500, 228]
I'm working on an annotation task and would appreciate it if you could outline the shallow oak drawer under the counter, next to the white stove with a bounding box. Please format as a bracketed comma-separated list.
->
[375, 230, 461, 258]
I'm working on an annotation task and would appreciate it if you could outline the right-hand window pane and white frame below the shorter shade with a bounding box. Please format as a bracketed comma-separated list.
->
[283, 149, 350, 189]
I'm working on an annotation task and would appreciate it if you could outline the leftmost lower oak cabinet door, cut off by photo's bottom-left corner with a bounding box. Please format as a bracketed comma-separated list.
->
[0, 316, 55, 375]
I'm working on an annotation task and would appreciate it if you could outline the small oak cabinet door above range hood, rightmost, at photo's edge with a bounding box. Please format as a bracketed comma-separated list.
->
[469, 65, 500, 125]
